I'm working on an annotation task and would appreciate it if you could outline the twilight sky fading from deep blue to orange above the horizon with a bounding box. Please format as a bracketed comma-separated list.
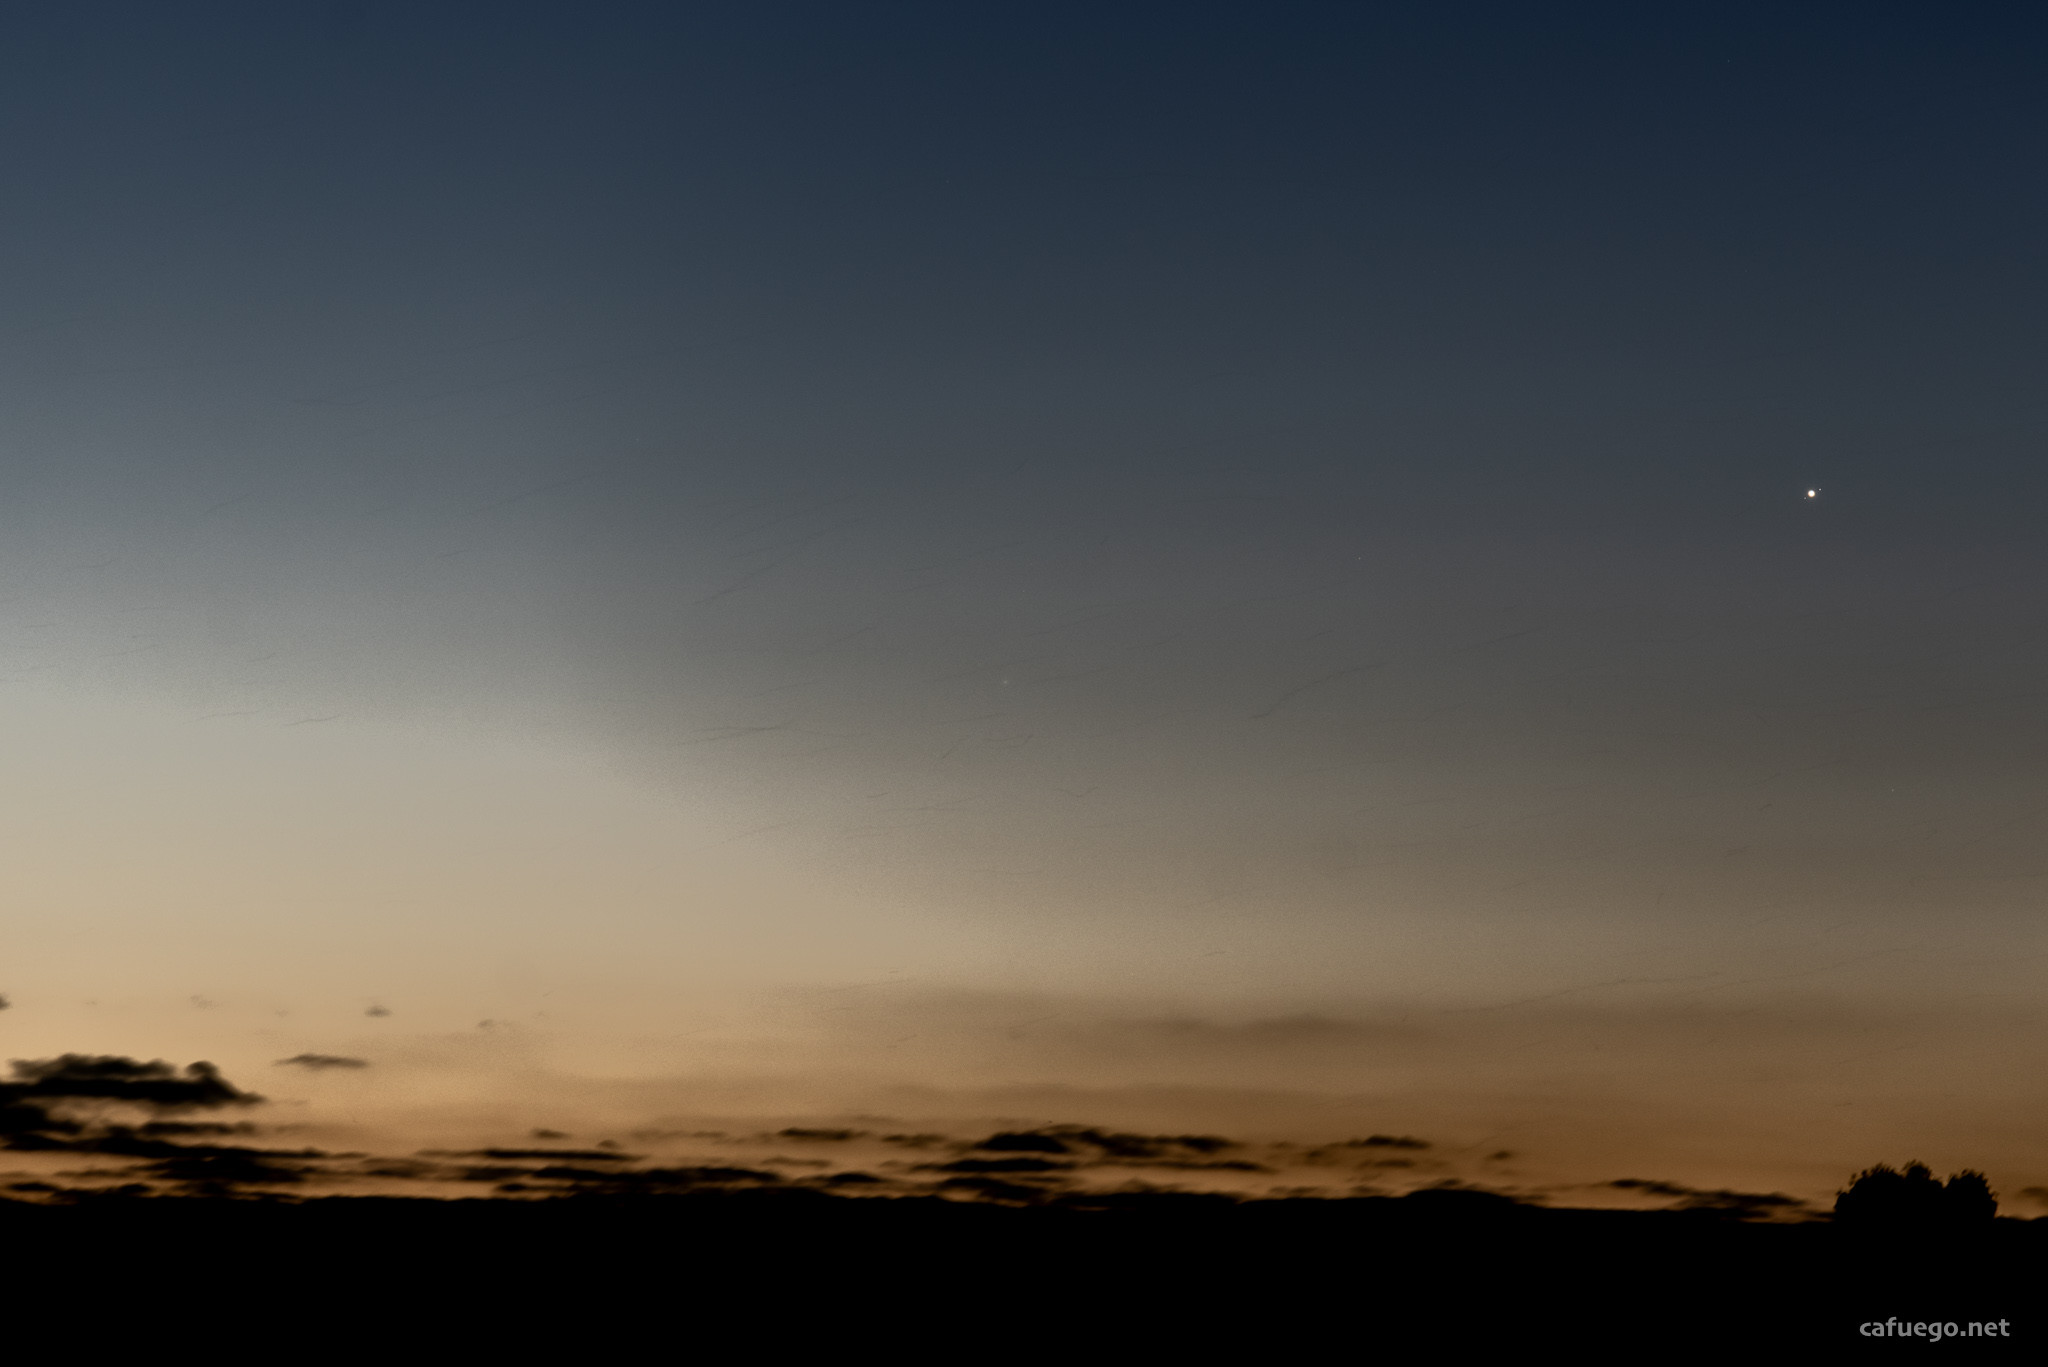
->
[0, 2, 2048, 1199]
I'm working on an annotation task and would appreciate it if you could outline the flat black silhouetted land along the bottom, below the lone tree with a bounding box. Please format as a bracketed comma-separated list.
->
[0, 1191, 2048, 1361]
